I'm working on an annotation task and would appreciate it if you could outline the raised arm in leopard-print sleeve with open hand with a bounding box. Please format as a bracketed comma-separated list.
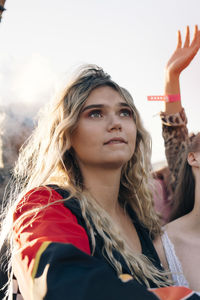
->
[160, 25, 200, 190]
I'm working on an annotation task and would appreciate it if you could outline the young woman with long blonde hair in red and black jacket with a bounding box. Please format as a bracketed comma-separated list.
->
[0, 66, 170, 300]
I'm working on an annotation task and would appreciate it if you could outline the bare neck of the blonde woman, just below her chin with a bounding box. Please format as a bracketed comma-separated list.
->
[81, 167, 121, 216]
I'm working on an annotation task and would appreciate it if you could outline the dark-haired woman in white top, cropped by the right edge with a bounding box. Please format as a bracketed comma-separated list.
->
[155, 134, 200, 295]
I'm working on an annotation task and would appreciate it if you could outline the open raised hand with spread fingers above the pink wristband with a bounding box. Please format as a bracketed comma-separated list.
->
[166, 25, 200, 76]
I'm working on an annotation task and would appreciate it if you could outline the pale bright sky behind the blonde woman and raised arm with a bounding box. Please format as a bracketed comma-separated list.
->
[0, 0, 200, 162]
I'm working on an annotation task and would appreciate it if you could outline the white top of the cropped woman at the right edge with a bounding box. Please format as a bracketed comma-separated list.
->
[161, 230, 200, 295]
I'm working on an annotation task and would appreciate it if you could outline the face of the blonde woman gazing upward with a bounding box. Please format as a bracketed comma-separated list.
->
[71, 86, 137, 168]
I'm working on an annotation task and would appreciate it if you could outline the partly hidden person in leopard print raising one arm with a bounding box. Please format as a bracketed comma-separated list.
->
[154, 25, 200, 224]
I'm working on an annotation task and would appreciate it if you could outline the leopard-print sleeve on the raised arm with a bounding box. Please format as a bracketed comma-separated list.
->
[160, 108, 189, 192]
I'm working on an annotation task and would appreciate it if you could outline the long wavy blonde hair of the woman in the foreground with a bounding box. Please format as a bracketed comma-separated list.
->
[0, 65, 167, 296]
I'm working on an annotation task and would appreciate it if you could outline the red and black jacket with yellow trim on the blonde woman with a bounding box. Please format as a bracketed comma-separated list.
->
[13, 186, 200, 300]
